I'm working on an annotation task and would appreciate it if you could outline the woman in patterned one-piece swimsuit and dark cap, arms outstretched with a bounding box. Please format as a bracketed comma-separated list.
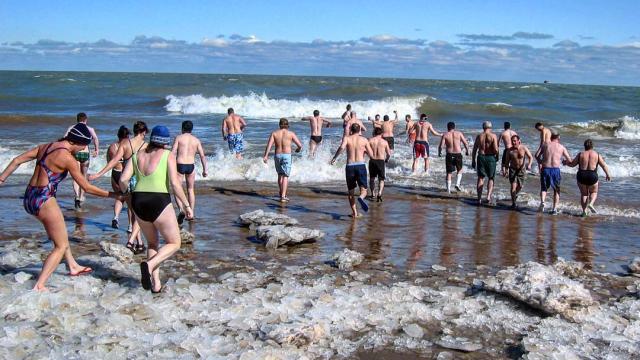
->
[0, 122, 123, 291]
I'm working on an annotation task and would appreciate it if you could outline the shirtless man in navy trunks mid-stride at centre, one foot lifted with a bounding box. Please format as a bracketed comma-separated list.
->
[331, 123, 373, 218]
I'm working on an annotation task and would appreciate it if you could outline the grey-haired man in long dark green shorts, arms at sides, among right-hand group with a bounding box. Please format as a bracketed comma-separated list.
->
[471, 121, 499, 205]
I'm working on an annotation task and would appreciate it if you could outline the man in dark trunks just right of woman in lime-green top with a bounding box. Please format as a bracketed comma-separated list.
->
[171, 120, 207, 224]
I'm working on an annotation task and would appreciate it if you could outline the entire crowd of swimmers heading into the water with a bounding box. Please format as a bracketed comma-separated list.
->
[0, 105, 611, 293]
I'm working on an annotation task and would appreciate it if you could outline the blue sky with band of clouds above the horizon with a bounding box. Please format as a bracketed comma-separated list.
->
[0, 0, 640, 86]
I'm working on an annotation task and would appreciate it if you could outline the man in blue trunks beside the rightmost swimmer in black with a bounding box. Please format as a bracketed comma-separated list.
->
[536, 129, 571, 215]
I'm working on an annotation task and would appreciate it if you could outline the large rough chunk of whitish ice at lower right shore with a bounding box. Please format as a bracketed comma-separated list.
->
[484, 261, 596, 319]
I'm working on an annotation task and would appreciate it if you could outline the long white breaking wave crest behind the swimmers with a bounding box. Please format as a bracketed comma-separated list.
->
[165, 93, 429, 119]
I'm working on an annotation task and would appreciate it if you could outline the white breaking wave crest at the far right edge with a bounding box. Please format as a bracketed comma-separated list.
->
[562, 115, 640, 140]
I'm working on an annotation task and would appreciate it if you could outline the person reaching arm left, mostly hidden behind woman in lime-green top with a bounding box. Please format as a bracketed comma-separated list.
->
[89, 121, 148, 255]
